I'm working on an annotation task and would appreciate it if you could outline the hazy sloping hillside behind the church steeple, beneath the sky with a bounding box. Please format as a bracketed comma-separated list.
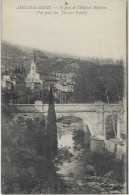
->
[1, 42, 123, 74]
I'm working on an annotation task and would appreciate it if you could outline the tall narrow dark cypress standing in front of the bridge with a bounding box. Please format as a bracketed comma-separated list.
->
[47, 86, 58, 155]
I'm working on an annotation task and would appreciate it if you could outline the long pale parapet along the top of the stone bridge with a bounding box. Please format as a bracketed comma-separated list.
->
[9, 104, 124, 113]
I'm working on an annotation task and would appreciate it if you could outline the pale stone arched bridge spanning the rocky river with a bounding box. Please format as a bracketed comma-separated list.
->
[10, 103, 125, 138]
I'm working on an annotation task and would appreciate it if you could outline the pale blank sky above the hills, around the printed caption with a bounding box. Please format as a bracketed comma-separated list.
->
[2, 0, 126, 58]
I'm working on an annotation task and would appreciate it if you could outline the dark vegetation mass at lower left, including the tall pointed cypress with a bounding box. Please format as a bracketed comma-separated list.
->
[1, 89, 64, 194]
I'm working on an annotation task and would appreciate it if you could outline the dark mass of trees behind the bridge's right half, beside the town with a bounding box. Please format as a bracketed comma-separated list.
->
[75, 63, 124, 103]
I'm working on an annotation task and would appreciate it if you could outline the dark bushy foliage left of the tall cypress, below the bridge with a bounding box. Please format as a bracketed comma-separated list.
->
[2, 112, 51, 194]
